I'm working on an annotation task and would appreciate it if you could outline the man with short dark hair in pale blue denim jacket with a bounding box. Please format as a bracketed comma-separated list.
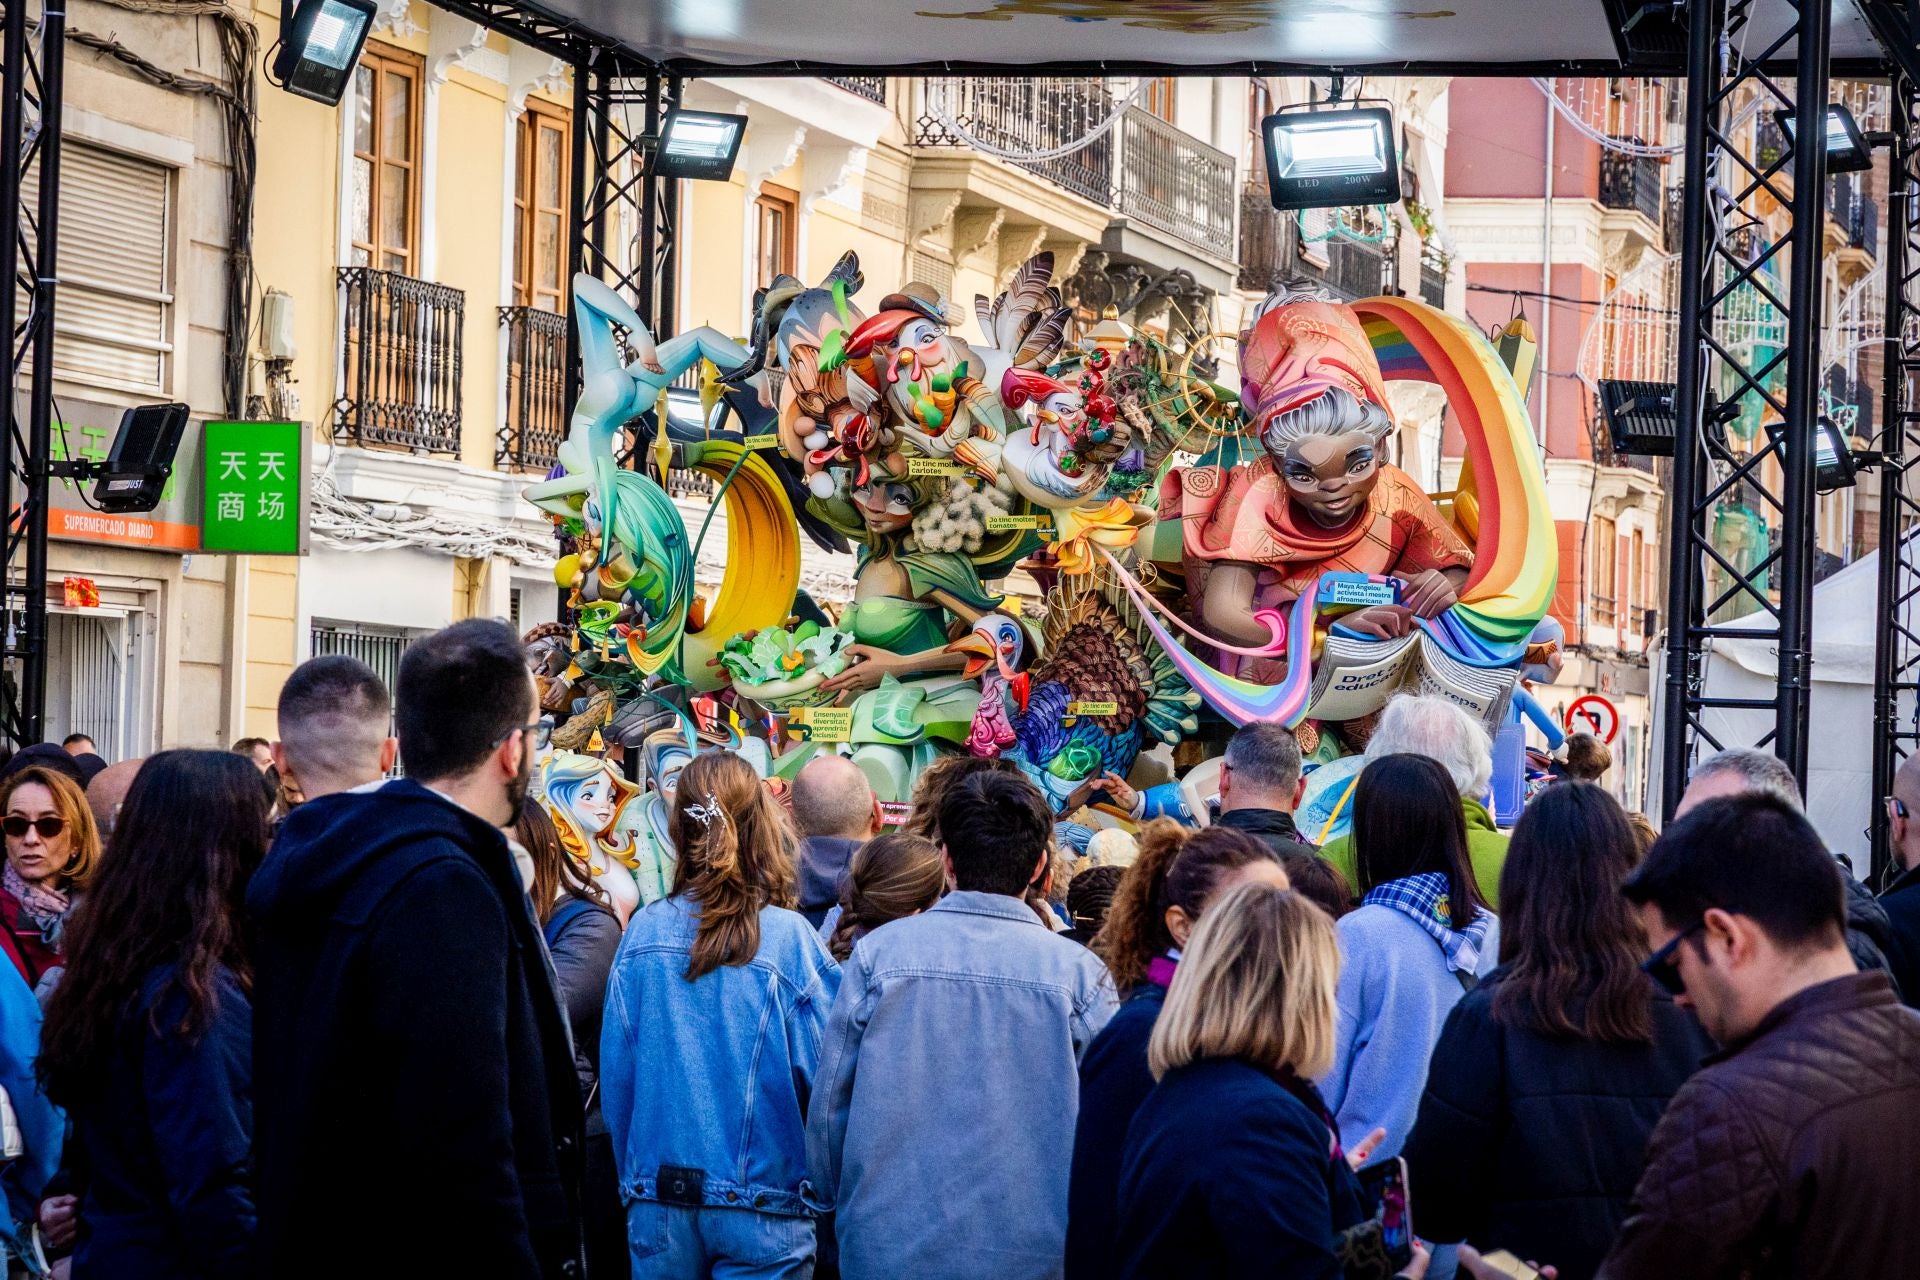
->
[806, 773, 1114, 1280]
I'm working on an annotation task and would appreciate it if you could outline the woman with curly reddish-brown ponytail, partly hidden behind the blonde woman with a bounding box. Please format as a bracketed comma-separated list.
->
[1066, 818, 1288, 1280]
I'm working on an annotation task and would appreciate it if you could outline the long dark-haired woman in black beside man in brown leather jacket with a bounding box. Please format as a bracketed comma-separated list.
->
[1404, 783, 1711, 1280]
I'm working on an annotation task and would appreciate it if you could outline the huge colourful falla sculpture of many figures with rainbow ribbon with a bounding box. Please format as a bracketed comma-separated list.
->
[528, 253, 1557, 855]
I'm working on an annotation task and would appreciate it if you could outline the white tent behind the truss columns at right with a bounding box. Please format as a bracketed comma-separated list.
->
[1647, 551, 1914, 875]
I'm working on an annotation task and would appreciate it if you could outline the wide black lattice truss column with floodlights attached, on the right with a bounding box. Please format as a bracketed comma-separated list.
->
[1661, 0, 1830, 816]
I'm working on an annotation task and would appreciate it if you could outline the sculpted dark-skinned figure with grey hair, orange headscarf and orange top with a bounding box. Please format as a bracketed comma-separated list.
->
[1160, 282, 1473, 681]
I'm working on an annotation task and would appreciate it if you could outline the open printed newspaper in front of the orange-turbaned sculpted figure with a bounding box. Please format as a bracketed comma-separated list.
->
[1308, 629, 1519, 725]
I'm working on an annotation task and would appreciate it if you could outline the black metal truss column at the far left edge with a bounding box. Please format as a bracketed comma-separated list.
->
[0, 0, 67, 745]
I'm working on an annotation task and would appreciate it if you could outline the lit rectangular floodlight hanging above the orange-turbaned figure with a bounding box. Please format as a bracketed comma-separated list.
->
[1260, 107, 1400, 209]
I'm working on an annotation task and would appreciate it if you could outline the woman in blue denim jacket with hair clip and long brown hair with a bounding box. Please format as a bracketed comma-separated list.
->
[601, 750, 839, 1280]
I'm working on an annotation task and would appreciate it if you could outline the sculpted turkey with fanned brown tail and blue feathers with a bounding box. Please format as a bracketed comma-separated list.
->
[948, 583, 1200, 810]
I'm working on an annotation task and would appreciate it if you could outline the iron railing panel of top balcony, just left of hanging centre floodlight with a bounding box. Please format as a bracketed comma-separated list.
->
[1114, 107, 1235, 257]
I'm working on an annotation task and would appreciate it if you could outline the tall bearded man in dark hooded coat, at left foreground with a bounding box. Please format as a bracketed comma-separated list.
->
[248, 620, 584, 1280]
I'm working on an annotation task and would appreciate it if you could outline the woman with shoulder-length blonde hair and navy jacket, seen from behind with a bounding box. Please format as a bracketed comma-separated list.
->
[1116, 883, 1427, 1280]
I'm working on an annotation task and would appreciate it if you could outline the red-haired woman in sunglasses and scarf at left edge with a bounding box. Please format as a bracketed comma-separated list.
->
[0, 766, 100, 1000]
